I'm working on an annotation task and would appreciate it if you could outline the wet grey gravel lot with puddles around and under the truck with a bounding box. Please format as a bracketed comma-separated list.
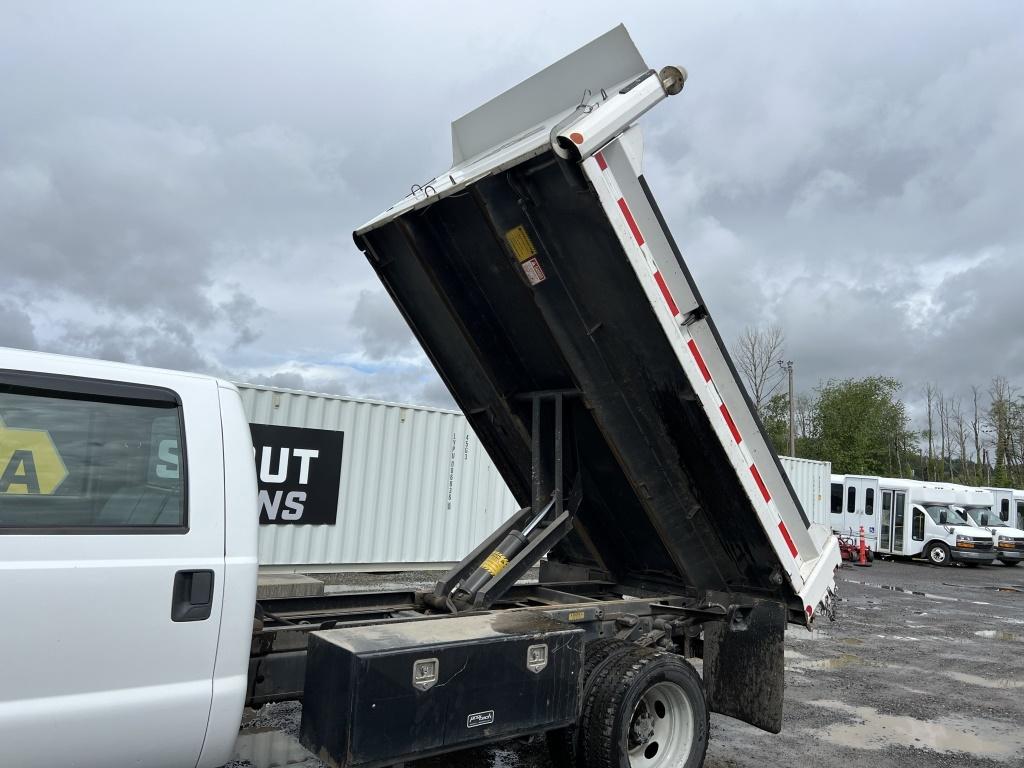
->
[224, 562, 1024, 768]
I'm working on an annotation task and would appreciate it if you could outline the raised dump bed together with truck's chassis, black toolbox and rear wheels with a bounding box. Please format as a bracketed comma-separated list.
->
[286, 28, 840, 768]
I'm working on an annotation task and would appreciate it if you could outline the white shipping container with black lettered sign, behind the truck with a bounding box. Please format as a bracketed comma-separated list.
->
[239, 384, 518, 571]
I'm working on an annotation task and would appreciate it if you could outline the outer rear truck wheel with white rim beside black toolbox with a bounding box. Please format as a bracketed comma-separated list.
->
[580, 648, 709, 768]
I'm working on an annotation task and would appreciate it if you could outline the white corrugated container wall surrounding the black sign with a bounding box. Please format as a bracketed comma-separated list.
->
[239, 384, 518, 569]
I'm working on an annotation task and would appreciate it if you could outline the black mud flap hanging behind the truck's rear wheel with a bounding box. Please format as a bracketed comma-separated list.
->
[703, 602, 786, 733]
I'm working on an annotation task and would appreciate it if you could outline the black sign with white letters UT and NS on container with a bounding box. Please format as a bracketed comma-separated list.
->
[249, 424, 345, 525]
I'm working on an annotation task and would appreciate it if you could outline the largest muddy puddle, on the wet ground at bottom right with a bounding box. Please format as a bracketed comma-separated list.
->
[807, 700, 1024, 760]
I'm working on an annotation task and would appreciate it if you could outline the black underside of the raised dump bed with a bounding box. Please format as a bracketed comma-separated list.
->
[355, 151, 788, 599]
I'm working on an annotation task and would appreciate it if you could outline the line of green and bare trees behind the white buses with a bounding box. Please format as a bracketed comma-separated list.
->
[734, 326, 1024, 488]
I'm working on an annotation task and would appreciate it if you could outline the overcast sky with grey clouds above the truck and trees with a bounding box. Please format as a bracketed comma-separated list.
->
[0, 0, 1024, 415]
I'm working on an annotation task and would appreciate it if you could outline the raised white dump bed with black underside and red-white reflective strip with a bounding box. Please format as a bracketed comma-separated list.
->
[355, 28, 840, 623]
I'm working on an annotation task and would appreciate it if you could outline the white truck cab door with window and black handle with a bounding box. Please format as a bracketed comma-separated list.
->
[0, 370, 224, 768]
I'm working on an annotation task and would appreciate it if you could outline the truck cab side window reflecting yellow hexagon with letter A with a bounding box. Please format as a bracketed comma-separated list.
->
[0, 372, 187, 534]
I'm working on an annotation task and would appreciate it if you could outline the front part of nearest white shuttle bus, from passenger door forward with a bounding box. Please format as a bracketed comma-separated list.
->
[877, 478, 995, 566]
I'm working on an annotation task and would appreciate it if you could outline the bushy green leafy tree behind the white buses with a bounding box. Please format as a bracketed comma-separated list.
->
[798, 376, 915, 476]
